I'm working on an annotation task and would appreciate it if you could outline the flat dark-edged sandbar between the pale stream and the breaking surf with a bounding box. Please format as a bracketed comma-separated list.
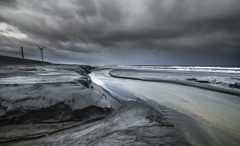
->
[109, 69, 240, 96]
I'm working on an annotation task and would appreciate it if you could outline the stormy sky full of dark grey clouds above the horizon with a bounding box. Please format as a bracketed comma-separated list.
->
[0, 0, 240, 66]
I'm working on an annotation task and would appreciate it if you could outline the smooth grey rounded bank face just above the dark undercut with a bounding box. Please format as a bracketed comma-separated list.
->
[0, 82, 111, 125]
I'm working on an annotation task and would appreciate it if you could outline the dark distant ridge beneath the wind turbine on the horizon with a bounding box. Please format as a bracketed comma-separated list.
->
[0, 55, 50, 66]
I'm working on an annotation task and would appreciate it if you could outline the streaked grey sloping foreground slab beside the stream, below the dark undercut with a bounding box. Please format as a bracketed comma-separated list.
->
[3, 102, 189, 146]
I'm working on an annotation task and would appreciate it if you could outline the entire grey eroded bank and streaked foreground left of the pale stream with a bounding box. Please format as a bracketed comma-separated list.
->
[0, 56, 189, 145]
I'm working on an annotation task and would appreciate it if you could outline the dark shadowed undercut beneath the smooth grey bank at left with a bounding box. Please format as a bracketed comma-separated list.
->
[0, 103, 111, 125]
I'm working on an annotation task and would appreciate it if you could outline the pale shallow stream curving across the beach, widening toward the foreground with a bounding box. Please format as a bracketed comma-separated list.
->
[90, 70, 240, 146]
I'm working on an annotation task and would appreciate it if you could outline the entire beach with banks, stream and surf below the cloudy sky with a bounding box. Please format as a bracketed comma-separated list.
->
[0, 55, 240, 146]
